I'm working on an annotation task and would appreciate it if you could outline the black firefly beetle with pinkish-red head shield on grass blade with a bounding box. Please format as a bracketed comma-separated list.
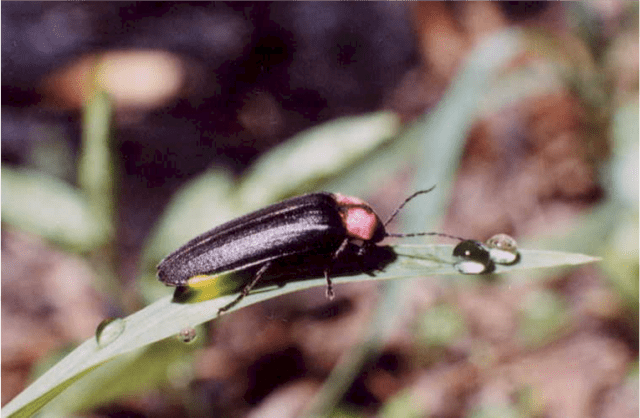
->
[158, 186, 461, 311]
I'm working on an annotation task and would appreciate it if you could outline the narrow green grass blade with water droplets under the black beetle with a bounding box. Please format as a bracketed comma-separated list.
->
[2, 245, 599, 417]
